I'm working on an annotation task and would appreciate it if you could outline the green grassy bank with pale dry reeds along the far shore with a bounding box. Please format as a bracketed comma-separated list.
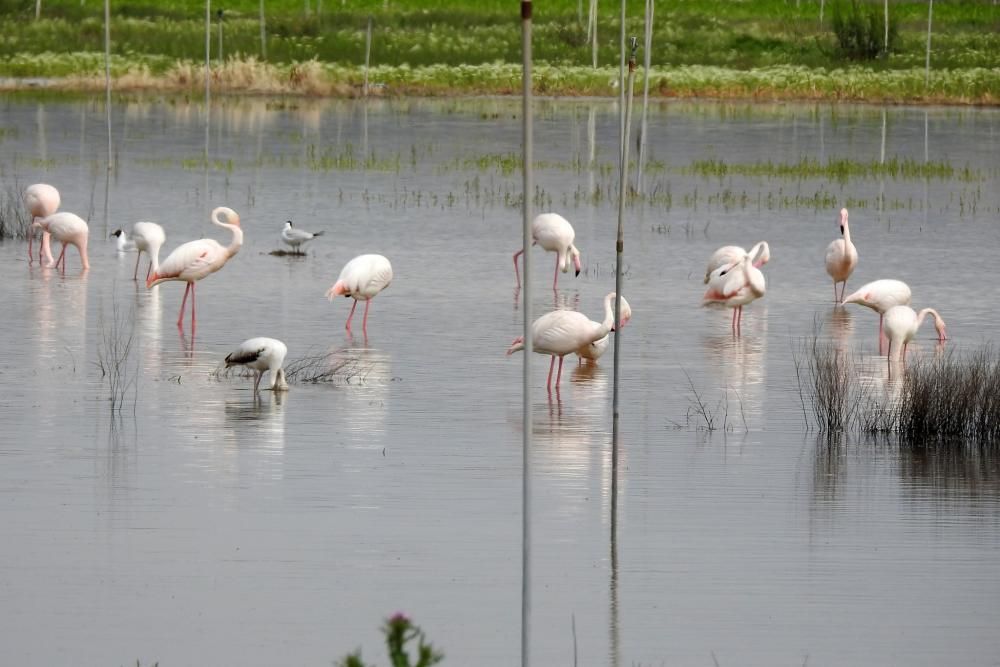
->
[0, 0, 1000, 104]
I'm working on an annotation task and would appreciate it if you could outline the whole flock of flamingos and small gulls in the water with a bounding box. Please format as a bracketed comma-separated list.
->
[23, 183, 947, 396]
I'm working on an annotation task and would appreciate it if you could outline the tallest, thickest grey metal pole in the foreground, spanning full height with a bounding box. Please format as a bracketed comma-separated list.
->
[521, 5, 534, 667]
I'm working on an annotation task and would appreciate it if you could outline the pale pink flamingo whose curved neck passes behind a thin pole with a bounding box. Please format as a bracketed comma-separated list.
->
[507, 292, 624, 393]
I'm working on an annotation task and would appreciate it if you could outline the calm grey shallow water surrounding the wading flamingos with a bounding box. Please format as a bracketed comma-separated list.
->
[0, 97, 1000, 666]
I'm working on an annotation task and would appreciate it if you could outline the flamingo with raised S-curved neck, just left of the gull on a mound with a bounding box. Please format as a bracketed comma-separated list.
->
[146, 206, 243, 330]
